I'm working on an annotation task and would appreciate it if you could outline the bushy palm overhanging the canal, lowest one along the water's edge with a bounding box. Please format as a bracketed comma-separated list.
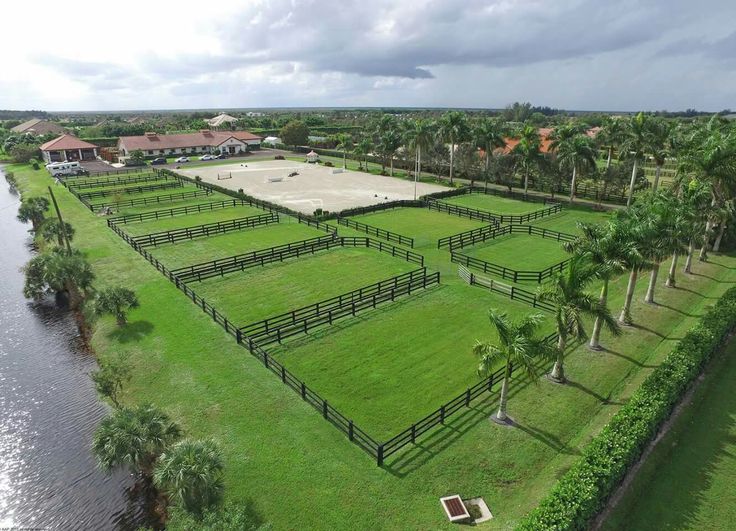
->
[92, 405, 181, 478]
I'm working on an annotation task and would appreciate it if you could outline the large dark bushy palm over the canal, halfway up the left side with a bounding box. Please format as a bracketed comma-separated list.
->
[23, 248, 94, 310]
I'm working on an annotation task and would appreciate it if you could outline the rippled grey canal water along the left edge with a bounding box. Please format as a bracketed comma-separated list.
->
[0, 166, 146, 530]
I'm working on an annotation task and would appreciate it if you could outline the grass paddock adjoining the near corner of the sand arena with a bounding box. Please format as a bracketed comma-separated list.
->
[350, 208, 488, 247]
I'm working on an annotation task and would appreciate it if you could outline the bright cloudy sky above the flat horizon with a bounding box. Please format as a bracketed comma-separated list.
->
[0, 0, 736, 111]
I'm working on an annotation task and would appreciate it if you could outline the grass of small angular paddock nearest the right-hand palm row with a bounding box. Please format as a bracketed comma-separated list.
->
[460, 234, 569, 271]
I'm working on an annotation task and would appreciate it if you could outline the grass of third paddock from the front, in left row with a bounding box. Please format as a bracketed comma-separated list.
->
[148, 223, 326, 269]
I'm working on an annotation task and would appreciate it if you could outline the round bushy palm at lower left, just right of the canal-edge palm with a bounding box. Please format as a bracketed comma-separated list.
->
[153, 439, 225, 514]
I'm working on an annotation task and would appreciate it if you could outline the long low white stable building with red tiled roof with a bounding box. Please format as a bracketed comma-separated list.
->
[118, 129, 261, 157]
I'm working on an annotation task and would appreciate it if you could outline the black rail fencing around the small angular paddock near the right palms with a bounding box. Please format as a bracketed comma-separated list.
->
[450, 225, 575, 283]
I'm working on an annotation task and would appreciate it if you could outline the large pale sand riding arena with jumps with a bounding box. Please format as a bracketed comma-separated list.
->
[176, 160, 447, 214]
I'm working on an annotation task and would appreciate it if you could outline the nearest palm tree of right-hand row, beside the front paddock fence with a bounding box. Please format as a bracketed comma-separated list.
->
[473, 310, 552, 422]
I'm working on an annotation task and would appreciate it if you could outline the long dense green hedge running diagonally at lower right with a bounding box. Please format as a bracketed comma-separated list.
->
[517, 288, 736, 531]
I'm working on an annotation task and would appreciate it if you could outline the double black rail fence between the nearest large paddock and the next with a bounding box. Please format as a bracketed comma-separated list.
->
[238, 267, 440, 346]
